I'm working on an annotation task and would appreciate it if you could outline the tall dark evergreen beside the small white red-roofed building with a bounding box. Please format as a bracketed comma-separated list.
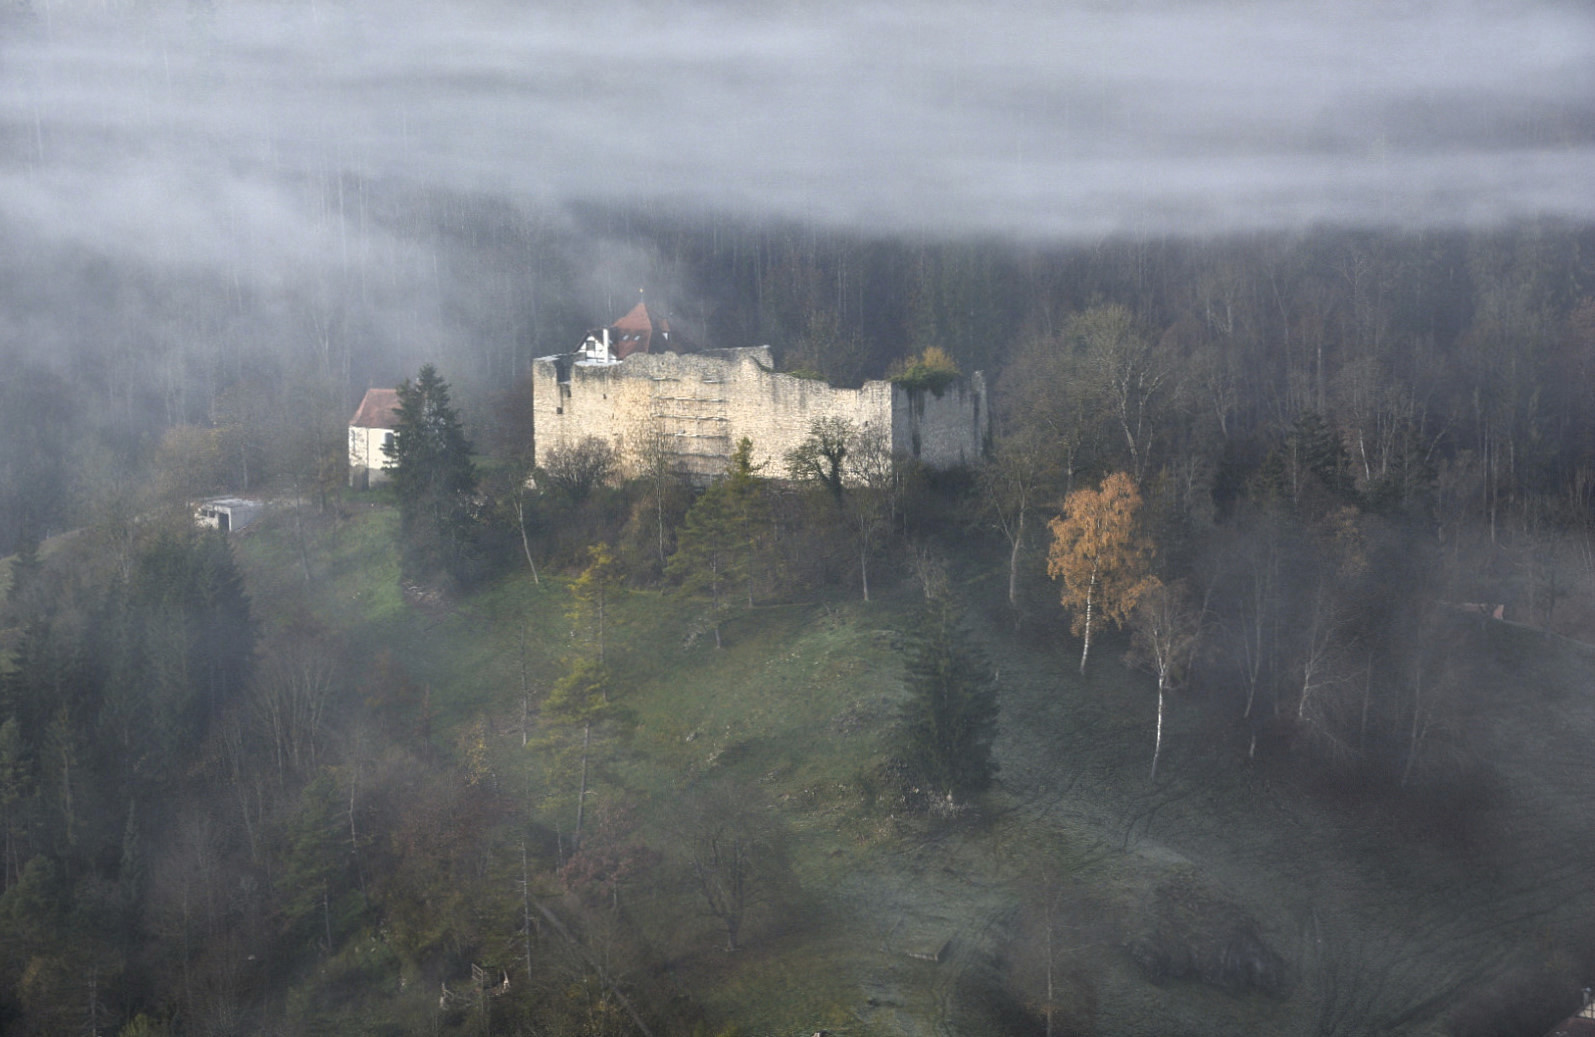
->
[383, 364, 477, 584]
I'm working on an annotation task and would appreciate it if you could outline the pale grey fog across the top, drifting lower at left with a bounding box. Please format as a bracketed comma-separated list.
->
[0, 0, 1595, 408]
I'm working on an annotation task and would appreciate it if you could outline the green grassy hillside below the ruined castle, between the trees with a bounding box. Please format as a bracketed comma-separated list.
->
[236, 497, 1595, 1035]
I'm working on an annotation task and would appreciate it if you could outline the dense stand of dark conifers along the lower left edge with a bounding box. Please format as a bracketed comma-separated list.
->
[0, 514, 255, 1032]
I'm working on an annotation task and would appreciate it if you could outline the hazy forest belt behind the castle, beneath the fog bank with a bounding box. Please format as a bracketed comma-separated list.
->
[0, 193, 1595, 552]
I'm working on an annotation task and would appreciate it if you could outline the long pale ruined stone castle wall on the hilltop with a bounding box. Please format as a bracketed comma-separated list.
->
[533, 346, 989, 479]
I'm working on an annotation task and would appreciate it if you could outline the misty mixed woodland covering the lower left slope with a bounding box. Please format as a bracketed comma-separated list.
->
[0, 509, 733, 1037]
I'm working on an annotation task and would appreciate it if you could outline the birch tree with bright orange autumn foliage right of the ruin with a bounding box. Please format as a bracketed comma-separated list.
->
[1046, 472, 1156, 673]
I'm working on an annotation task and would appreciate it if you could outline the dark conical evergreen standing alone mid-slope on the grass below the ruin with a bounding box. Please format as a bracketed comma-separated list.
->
[901, 595, 997, 801]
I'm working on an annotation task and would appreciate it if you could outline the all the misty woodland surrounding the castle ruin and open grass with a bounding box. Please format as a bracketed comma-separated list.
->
[0, 207, 1595, 1035]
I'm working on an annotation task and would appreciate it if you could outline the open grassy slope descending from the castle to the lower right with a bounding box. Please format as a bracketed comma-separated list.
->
[239, 509, 1595, 1034]
